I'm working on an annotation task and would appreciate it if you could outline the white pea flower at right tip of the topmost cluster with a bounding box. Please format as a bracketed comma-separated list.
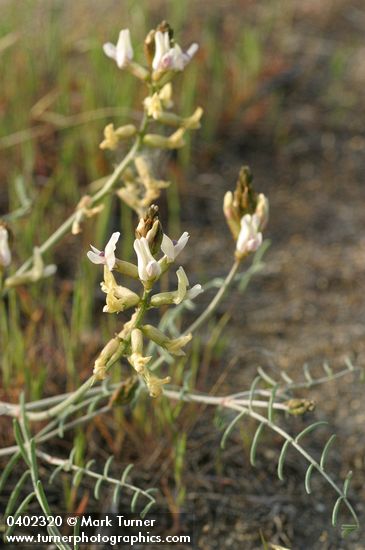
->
[152, 31, 199, 71]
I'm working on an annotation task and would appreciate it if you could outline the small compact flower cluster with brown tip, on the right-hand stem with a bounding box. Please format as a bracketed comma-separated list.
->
[223, 167, 269, 260]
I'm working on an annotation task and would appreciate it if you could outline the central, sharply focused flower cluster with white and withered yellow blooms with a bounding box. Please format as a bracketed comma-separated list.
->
[87, 206, 203, 397]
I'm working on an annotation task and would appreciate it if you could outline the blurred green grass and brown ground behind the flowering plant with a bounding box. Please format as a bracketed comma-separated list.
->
[0, 0, 365, 549]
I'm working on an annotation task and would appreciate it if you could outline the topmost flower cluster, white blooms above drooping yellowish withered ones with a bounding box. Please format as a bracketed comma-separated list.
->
[100, 21, 203, 220]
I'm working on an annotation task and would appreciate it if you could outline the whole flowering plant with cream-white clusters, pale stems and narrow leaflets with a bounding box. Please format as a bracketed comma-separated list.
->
[0, 21, 359, 548]
